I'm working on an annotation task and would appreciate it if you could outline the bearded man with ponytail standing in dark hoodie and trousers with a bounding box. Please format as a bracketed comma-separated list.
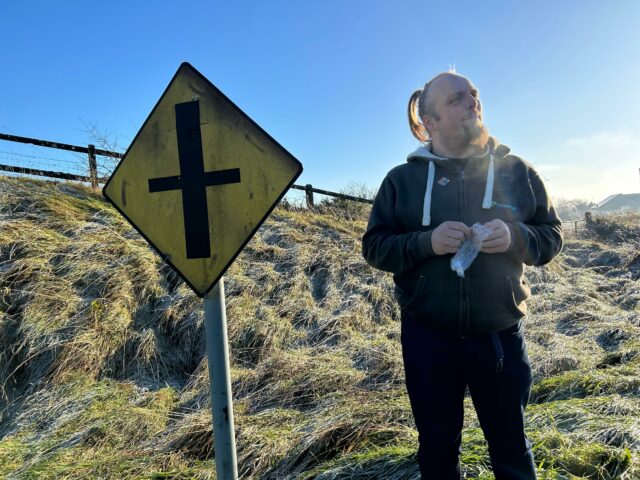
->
[362, 72, 562, 480]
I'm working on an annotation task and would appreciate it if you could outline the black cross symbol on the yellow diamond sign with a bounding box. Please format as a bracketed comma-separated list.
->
[149, 100, 240, 258]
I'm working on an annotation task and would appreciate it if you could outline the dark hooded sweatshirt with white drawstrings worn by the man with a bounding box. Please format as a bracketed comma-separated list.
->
[362, 138, 563, 336]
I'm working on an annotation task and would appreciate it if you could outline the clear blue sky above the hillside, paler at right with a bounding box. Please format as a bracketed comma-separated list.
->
[0, 0, 640, 201]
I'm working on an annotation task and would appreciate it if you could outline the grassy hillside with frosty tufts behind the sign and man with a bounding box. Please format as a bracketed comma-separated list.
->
[0, 177, 640, 480]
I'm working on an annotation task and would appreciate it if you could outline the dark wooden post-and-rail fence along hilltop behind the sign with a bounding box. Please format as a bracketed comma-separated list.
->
[0, 133, 373, 208]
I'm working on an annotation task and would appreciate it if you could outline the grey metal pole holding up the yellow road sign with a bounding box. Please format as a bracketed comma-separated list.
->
[204, 277, 238, 480]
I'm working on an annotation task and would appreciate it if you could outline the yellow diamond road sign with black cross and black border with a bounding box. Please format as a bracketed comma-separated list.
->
[103, 63, 302, 296]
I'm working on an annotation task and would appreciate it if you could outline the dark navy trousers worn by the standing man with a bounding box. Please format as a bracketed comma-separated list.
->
[401, 313, 536, 480]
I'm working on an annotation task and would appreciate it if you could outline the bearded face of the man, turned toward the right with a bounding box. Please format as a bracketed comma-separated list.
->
[424, 75, 489, 149]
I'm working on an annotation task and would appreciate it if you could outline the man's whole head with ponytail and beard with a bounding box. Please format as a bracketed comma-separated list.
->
[409, 72, 489, 152]
